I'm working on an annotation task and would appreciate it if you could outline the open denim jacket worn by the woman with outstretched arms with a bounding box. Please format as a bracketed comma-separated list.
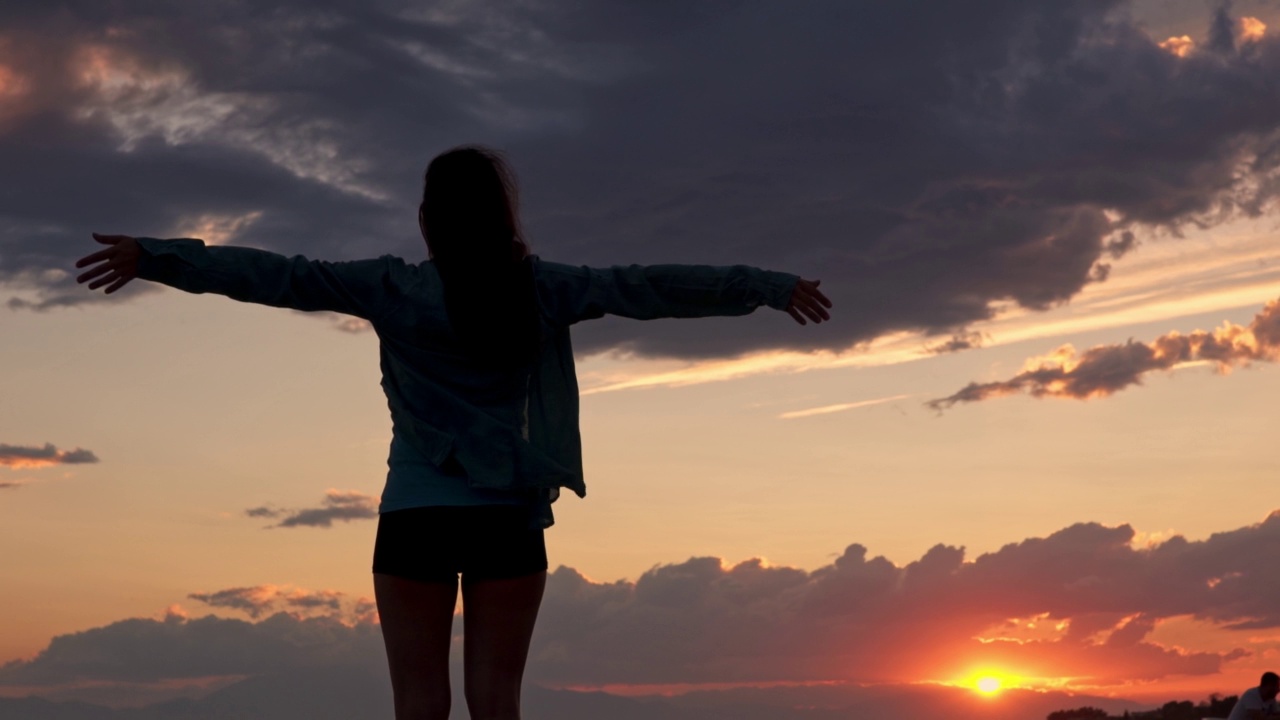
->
[138, 237, 799, 527]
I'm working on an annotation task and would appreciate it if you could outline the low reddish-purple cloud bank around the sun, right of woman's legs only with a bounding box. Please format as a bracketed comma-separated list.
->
[530, 512, 1280, 685]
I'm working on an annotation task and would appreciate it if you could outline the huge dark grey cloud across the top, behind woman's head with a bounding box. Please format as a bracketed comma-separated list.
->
[0, 0, 1280, 356]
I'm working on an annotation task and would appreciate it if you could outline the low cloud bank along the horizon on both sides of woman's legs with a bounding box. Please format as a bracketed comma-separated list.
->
[0, 511, 1280, 691]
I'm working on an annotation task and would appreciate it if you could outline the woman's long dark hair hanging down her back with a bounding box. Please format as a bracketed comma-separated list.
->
[419, 145, 540, 368]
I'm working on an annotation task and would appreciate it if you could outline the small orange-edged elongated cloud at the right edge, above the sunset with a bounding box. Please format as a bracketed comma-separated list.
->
[927, 292, 1280, 410]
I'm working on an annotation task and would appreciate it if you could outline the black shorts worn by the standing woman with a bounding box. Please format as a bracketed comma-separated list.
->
[374, 505, 547, 583]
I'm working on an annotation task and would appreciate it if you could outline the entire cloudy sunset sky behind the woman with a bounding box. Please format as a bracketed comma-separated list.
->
[0, 0, 1280, 717]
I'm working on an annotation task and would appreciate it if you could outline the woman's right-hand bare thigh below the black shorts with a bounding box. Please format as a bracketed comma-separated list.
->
[462, 570, 547, 720]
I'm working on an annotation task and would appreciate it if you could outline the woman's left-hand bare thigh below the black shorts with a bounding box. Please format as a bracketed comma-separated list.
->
[374, 573, 458, 720]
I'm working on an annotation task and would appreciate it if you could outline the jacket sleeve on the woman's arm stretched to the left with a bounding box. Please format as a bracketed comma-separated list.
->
[137, 237, 403, 320]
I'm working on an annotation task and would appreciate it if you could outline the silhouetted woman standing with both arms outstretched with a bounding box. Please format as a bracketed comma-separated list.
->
[76, 146, 831, 720]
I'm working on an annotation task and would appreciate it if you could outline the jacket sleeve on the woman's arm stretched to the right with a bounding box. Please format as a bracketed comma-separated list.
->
[538, 256, 800, 325]
